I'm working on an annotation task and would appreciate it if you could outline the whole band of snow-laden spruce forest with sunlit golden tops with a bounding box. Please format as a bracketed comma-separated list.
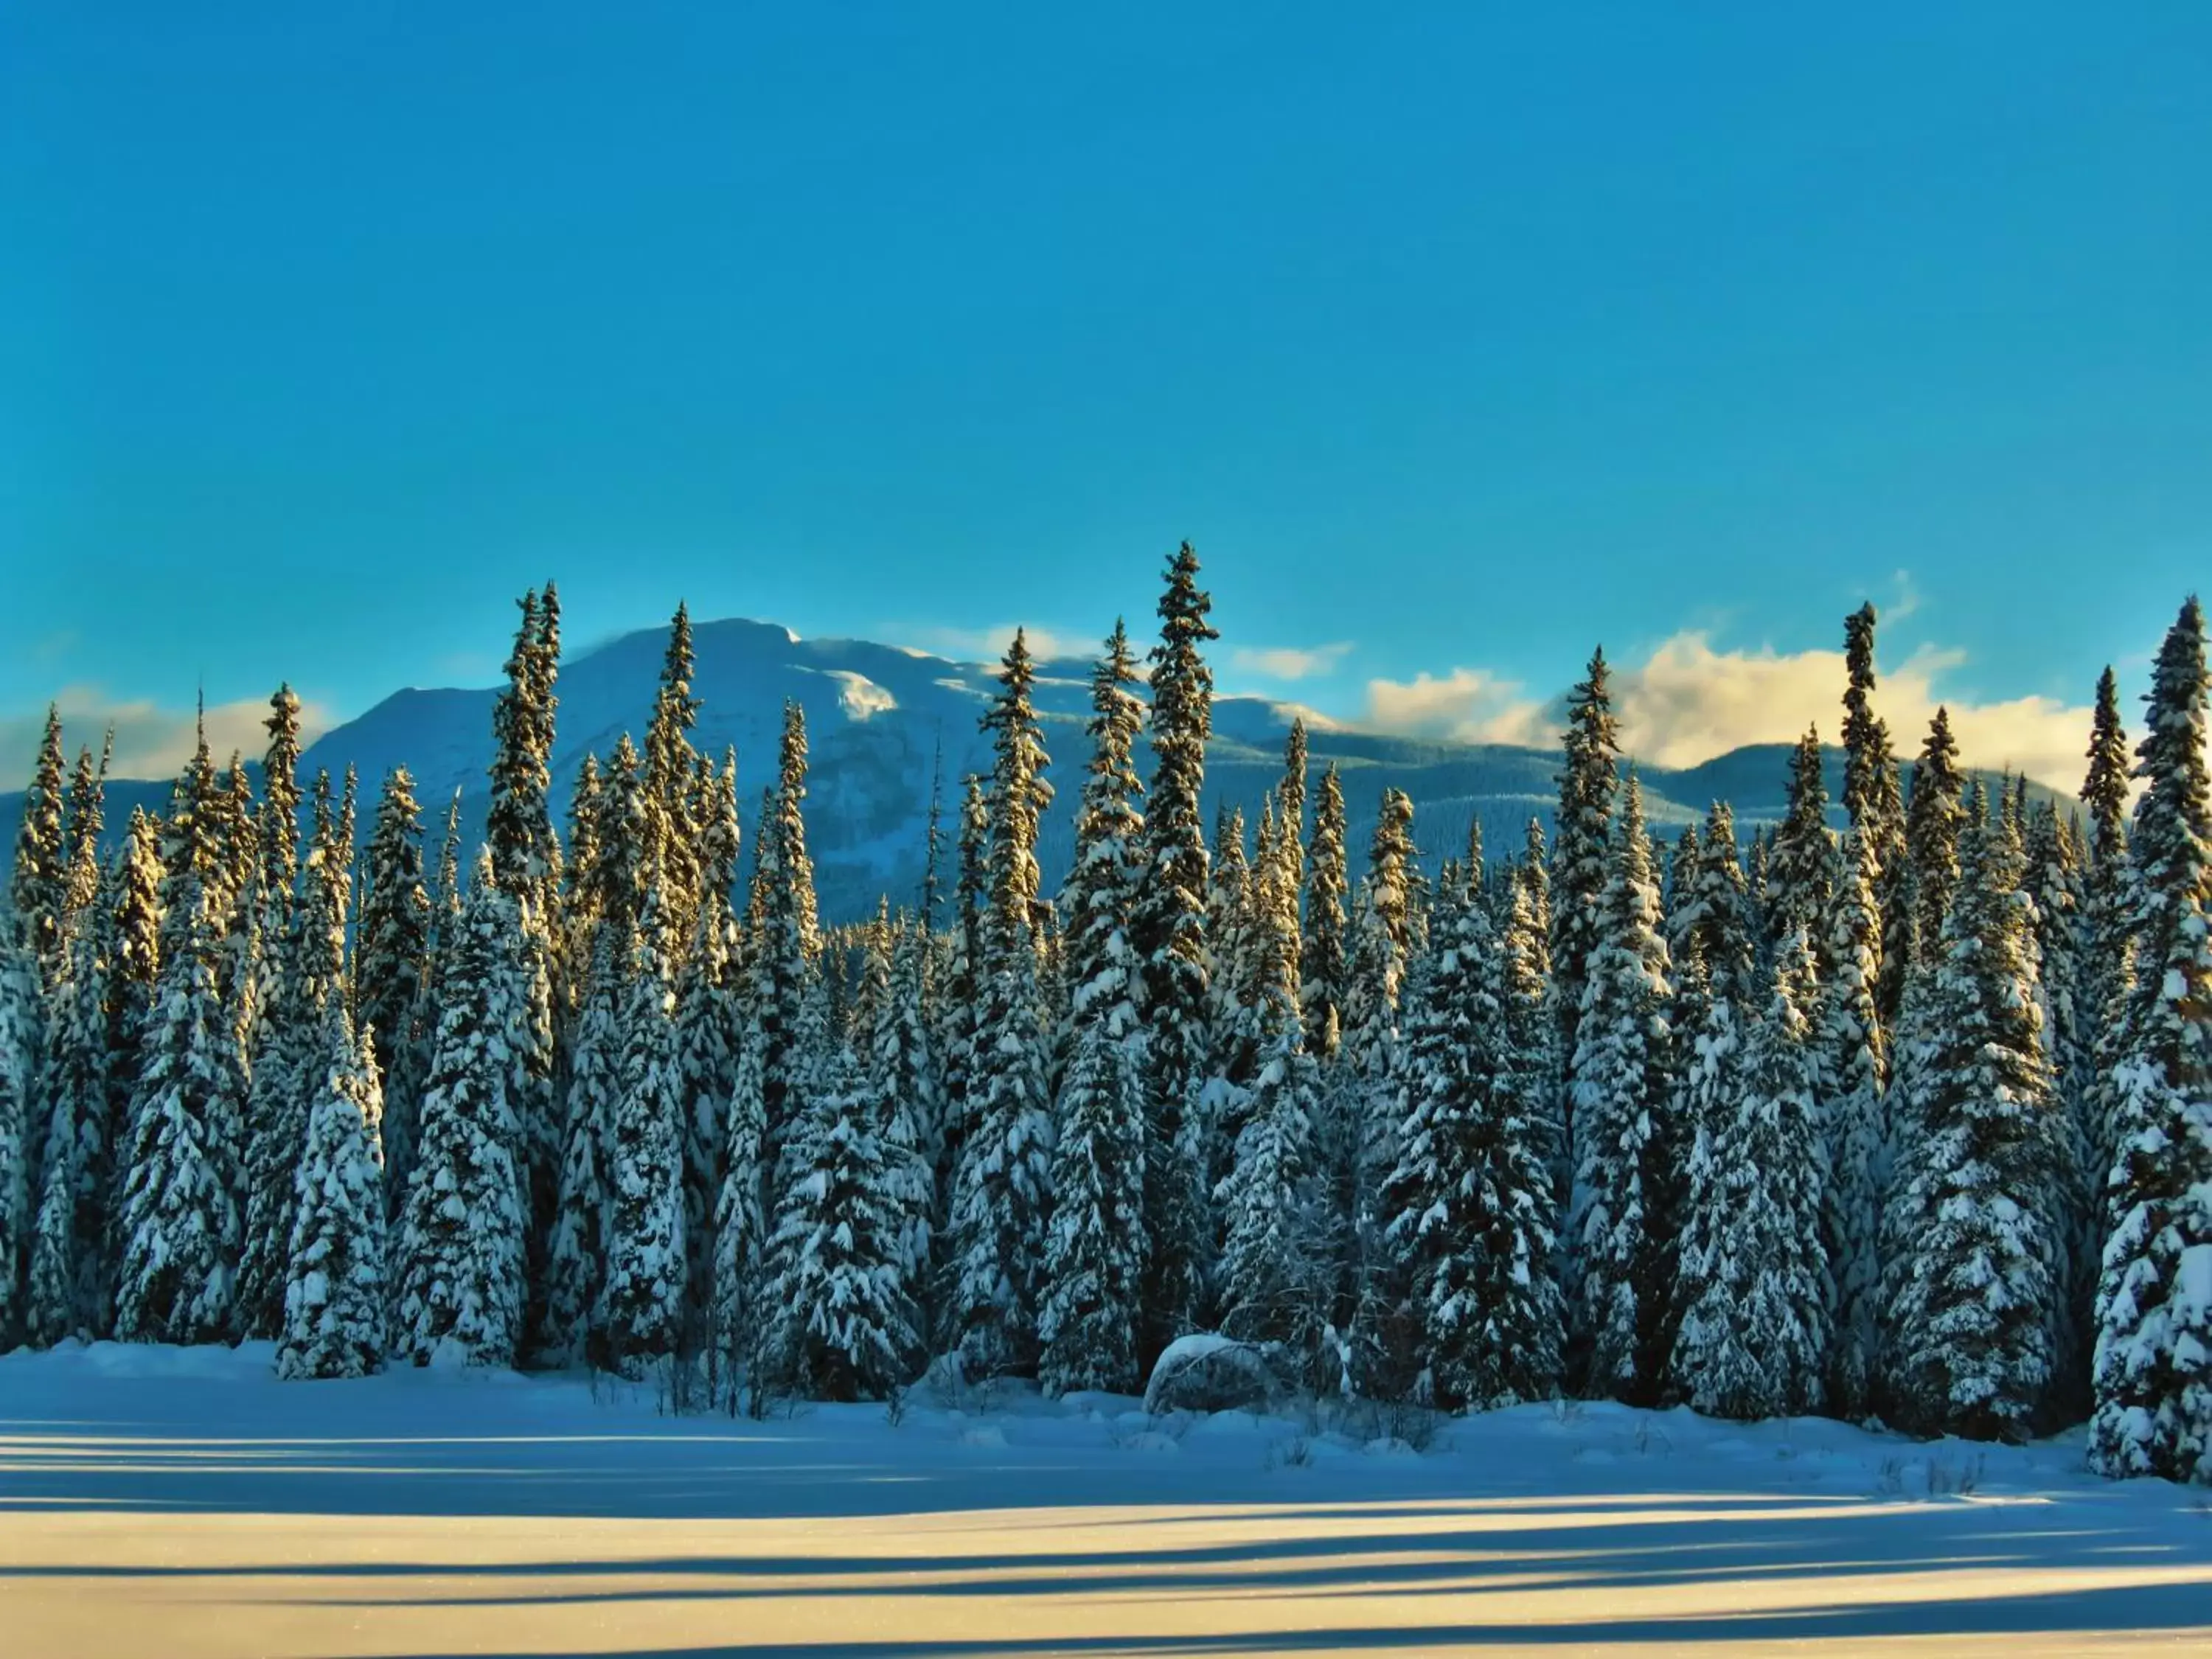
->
[0, 544, 2212, 1482]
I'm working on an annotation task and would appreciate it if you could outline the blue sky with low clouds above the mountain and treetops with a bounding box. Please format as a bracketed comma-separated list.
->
[0, 0, 2212, 787]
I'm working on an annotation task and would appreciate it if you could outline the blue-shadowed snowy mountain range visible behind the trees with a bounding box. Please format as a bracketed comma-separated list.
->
[0, 619, 2039, 922]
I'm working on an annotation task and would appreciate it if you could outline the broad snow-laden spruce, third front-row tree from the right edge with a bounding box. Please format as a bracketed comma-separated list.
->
[1674, 929, 1827, 1418]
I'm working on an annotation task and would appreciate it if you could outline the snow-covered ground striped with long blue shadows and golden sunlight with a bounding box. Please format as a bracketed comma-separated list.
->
[0, 1345, 2212, 1659]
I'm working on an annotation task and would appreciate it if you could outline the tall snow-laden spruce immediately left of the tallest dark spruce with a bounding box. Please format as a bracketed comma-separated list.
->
[1037, 622, 1146, 1396]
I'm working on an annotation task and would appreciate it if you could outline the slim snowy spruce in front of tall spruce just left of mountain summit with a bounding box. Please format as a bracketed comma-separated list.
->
[599, 885, 686, 1378]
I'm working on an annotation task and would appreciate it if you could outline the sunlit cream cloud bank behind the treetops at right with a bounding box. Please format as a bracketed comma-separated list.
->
[1365, 633, 2090, 792]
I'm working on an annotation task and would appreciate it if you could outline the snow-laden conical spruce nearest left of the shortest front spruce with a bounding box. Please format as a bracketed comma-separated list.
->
[115, 858, 239, 1343]
